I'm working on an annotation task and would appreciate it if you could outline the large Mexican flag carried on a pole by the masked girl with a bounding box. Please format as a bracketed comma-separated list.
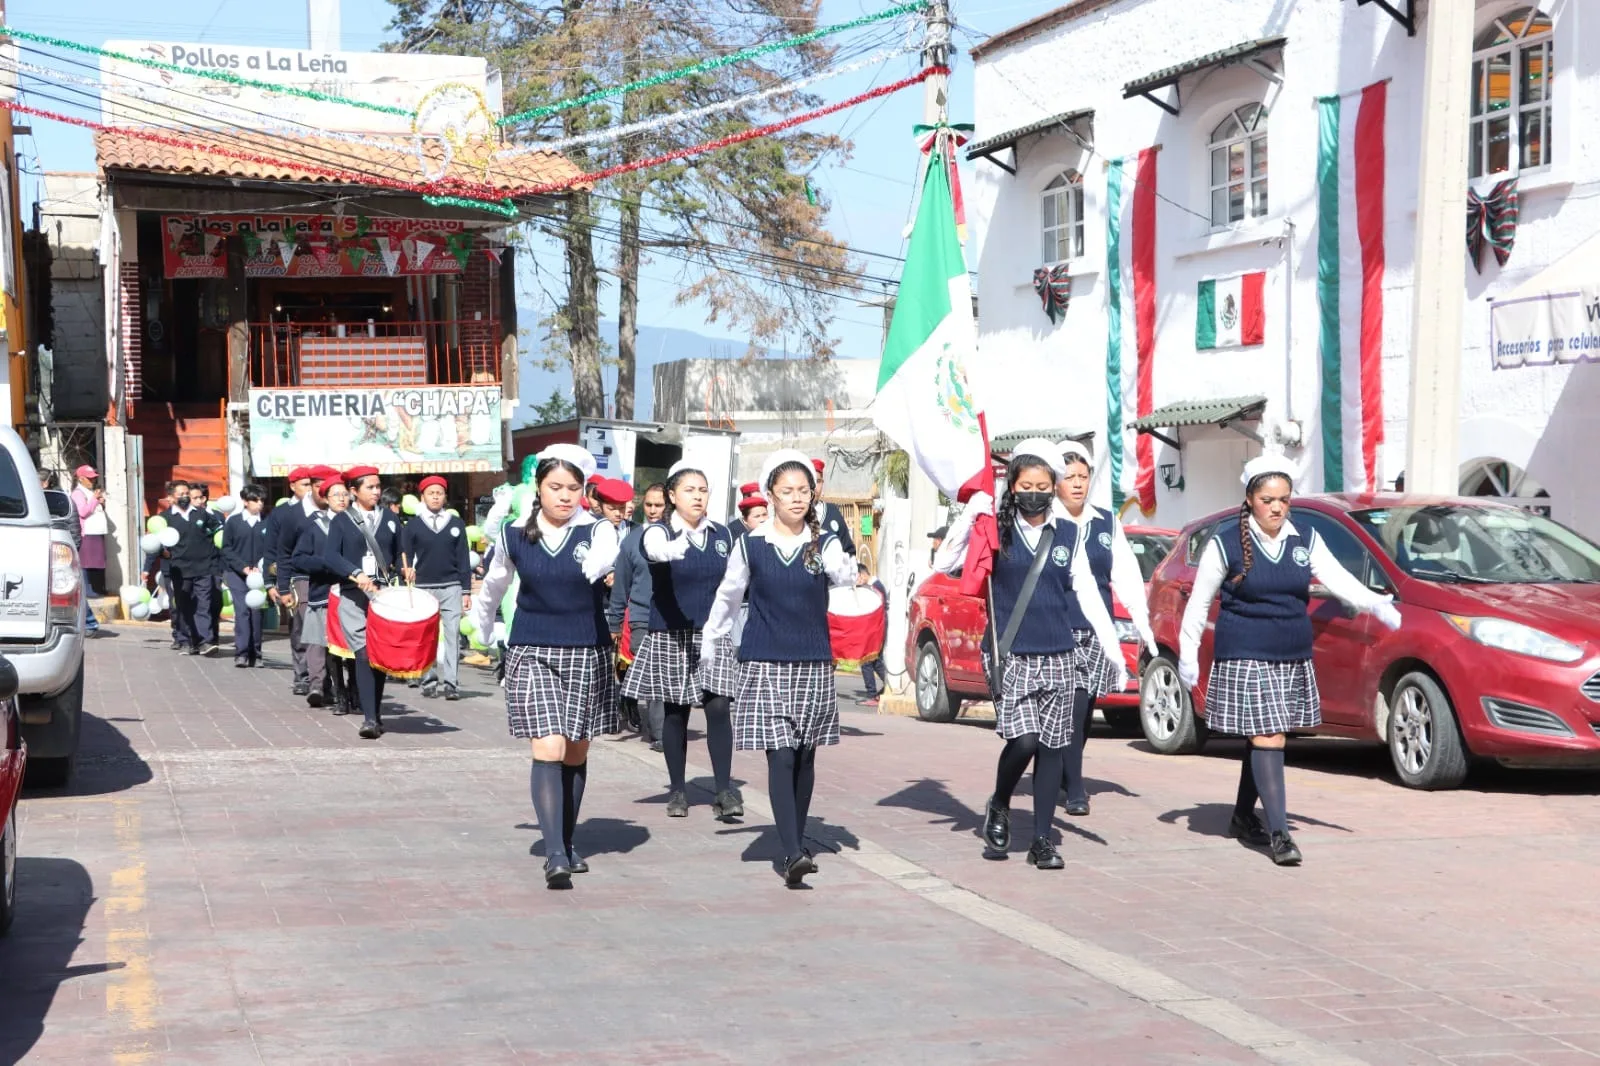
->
[872, 135, 998, 589]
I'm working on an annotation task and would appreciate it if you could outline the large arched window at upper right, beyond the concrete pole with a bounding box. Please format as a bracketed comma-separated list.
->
[1467, 8, 1555, 178]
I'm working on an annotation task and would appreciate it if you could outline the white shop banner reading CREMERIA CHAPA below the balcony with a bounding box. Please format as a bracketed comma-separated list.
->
[250, 386, 504, 477]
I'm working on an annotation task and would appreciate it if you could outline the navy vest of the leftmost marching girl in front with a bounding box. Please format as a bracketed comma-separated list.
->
[502, 517, 611, 648]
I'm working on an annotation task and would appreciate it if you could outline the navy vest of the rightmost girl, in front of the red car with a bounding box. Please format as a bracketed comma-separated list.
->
[1211, 523, 1315, 663]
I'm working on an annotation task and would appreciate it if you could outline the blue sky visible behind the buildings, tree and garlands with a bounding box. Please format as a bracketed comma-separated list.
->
[6, 0, 1056, 403]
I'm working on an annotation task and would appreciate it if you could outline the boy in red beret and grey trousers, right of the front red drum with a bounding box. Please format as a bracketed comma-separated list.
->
[400, 475, 472, 699]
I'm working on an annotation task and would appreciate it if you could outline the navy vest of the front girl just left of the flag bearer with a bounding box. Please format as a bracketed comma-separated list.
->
[739, 533, 837, 663]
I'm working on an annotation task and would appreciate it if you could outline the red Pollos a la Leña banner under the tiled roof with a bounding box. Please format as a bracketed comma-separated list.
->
[162, 213, 491, 279]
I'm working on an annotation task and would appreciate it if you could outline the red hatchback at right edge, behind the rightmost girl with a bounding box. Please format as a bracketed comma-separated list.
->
[1139, 493, 1600, 789]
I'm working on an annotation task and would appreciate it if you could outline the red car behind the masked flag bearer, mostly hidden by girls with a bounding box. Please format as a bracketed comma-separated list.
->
[906, 525, 1178, 726]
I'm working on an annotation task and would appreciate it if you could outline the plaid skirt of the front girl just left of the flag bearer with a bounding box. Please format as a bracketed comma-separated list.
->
[733, 663, 838, 751]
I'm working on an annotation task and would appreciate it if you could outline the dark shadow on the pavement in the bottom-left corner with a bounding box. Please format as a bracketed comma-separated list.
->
[0, 856, 123, 1063]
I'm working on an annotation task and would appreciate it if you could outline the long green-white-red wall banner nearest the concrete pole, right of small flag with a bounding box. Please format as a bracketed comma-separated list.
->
[1317, 82, 1389, 493]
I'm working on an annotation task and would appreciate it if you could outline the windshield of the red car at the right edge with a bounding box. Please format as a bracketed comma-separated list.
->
[1350, 504, 1600, 584]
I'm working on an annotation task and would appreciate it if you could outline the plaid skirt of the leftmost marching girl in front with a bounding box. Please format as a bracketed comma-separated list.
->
[506, 643, 622, 739]
